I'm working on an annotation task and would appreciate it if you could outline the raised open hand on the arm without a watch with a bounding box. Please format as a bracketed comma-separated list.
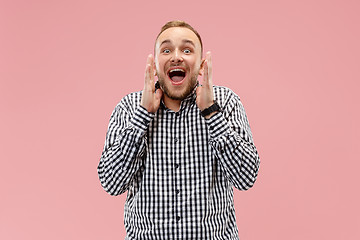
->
[140, 54, 162, 113]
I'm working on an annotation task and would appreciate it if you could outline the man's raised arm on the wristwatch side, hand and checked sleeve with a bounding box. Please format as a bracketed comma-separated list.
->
[196, 52, 260, 190]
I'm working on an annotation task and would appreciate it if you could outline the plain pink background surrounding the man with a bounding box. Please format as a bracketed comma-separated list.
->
[0, 0, 360, 240]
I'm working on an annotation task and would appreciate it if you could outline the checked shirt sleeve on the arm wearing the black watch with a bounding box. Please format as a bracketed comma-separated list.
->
[206, 90, 260, 190]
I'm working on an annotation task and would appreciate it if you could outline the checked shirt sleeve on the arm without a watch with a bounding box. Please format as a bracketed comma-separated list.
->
[97, 102, 154, 195]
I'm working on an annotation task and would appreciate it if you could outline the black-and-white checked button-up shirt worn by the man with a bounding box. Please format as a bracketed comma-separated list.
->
[98, 86, 260, 240]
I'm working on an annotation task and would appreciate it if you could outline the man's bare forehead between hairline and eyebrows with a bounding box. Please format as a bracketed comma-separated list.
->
[156, 27, 201, 48]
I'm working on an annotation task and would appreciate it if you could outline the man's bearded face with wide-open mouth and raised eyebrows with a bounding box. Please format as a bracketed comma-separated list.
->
[155, 27, 202, 100]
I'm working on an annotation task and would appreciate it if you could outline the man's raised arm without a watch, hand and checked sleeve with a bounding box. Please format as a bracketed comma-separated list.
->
[98, 55, 162, 195]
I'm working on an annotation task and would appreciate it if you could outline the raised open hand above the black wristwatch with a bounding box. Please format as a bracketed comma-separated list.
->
[196, 52, 214, 117]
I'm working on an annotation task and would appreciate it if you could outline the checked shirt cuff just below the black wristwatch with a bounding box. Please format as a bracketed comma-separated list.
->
[205, 112, 231, 138]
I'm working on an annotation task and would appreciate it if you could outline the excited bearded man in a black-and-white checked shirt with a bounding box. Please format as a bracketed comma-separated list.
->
[98, 21, 260, 240]
